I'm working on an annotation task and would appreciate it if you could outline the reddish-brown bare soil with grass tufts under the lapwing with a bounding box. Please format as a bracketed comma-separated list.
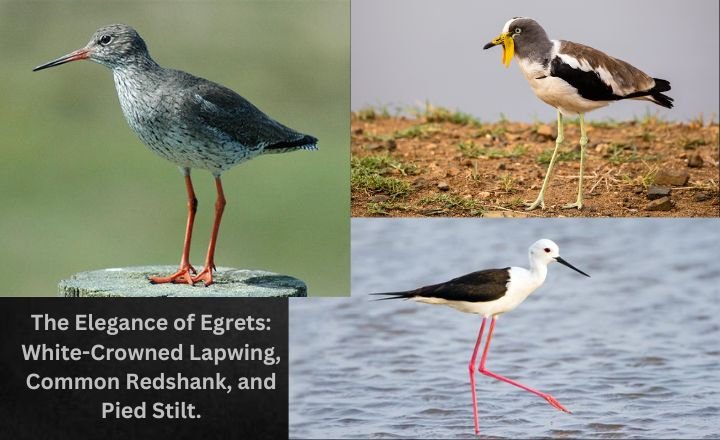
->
[352, 108, 720, 217]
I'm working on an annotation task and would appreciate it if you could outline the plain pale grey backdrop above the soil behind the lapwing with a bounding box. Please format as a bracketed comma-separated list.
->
[351, 0, 720, 121]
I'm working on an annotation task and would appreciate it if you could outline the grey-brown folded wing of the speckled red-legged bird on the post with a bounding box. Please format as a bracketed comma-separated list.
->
[185, 78, 317, 153]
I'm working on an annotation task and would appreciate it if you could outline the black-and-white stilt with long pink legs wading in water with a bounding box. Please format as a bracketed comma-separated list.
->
[372, 239, 590, 434]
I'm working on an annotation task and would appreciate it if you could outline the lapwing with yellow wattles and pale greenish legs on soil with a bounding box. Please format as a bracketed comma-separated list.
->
[483, 17, 673, 211]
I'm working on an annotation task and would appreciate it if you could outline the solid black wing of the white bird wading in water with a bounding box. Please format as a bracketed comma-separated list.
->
[372, 267, 510, 302]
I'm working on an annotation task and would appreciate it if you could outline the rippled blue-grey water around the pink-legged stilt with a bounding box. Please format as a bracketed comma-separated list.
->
[290, 219, 720, 438]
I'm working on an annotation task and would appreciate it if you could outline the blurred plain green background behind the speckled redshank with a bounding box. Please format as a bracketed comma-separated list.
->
[0, 0, 350, 296]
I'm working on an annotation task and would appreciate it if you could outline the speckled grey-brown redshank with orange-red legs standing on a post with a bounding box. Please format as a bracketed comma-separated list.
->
[33, 24, 317, 286]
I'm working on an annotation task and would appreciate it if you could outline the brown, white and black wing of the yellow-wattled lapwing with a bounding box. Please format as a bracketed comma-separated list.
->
[550, 40, 673, 108]
